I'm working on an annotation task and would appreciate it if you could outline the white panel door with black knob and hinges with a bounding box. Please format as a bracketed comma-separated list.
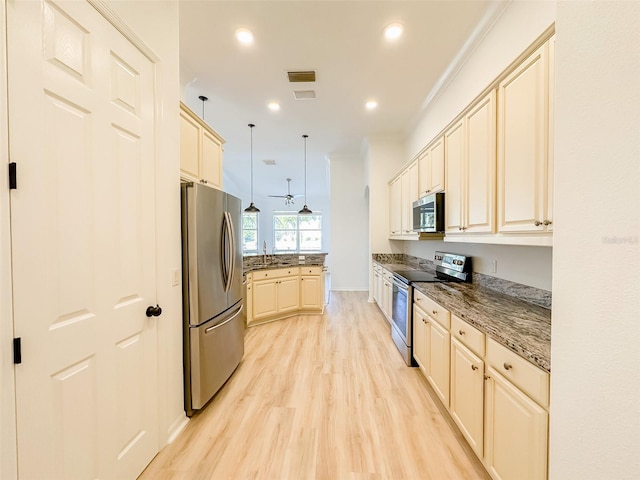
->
[7, 1, 158, 479]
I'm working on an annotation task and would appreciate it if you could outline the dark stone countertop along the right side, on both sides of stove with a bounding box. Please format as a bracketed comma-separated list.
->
[376, 262, 551, 372]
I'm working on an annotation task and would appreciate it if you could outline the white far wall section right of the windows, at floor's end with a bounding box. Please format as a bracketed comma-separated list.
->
[330, 155, 370, 290]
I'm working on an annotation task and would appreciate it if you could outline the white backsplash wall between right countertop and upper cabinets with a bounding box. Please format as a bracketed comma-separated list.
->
[404, 240, 553, 291]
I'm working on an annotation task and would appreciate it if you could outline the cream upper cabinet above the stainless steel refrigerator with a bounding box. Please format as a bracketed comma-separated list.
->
[180, 103, 224, 189]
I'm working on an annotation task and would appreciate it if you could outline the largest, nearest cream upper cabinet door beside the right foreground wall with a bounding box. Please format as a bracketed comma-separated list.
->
[497, 43, 551, 233]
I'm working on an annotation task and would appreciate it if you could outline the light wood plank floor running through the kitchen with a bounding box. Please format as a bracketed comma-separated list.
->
[140, 292, 489, 480]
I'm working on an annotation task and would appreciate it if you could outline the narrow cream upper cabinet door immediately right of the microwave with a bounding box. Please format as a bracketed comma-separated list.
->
[444, 120, 465, 233]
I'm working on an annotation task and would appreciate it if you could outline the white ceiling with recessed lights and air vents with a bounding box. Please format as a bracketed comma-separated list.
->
[180, 0, 493, 202]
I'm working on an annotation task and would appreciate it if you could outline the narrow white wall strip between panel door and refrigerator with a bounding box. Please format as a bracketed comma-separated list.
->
[110, 0, 186, 447]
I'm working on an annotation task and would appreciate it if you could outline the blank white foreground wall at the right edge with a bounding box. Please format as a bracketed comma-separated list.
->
[550, 2, 640, 480]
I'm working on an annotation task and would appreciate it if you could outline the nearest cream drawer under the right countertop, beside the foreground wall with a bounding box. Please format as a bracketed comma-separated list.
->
[485, 338, 549, 408]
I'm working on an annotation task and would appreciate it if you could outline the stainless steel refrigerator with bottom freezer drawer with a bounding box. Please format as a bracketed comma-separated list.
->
[181, 183, 246, 416]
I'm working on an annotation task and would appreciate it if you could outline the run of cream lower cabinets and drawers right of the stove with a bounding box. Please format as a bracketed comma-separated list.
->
[413, 298, 549, 480]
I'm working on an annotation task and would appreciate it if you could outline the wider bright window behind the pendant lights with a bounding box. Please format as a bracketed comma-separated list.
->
[273, 212, 322, 253]
